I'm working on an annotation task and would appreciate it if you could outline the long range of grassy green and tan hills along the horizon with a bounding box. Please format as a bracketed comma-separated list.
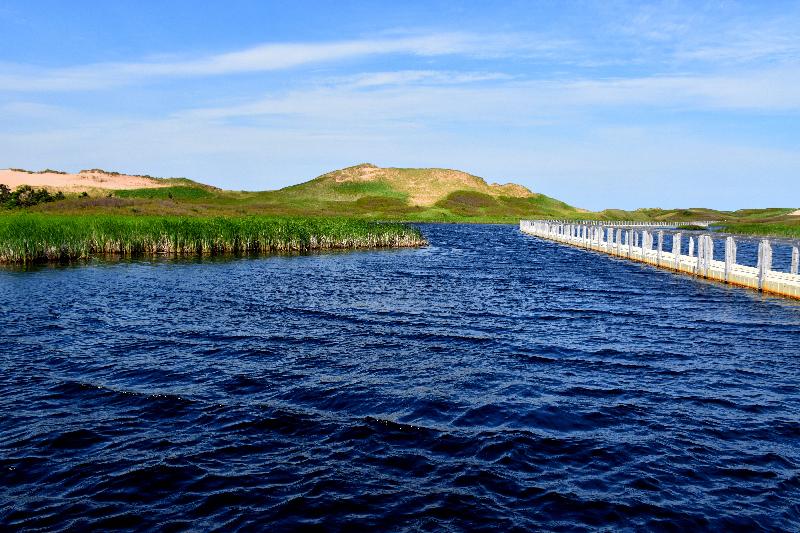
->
[6, 163, 800, 235]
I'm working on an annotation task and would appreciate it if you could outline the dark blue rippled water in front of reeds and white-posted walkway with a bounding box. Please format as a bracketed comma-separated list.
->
[0, 225, 800, 531]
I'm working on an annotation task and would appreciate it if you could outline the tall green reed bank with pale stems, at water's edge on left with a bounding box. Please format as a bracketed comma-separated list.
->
[0, 213, 425, 263]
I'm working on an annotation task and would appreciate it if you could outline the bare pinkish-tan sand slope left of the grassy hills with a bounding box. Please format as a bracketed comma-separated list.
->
[0, 169, 169, 192]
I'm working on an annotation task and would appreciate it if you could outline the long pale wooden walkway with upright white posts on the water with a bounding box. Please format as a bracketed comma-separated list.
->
[519, 220, 800, 298]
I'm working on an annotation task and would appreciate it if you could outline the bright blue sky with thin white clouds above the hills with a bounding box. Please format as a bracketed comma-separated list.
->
[0, 0, 800, 209]
